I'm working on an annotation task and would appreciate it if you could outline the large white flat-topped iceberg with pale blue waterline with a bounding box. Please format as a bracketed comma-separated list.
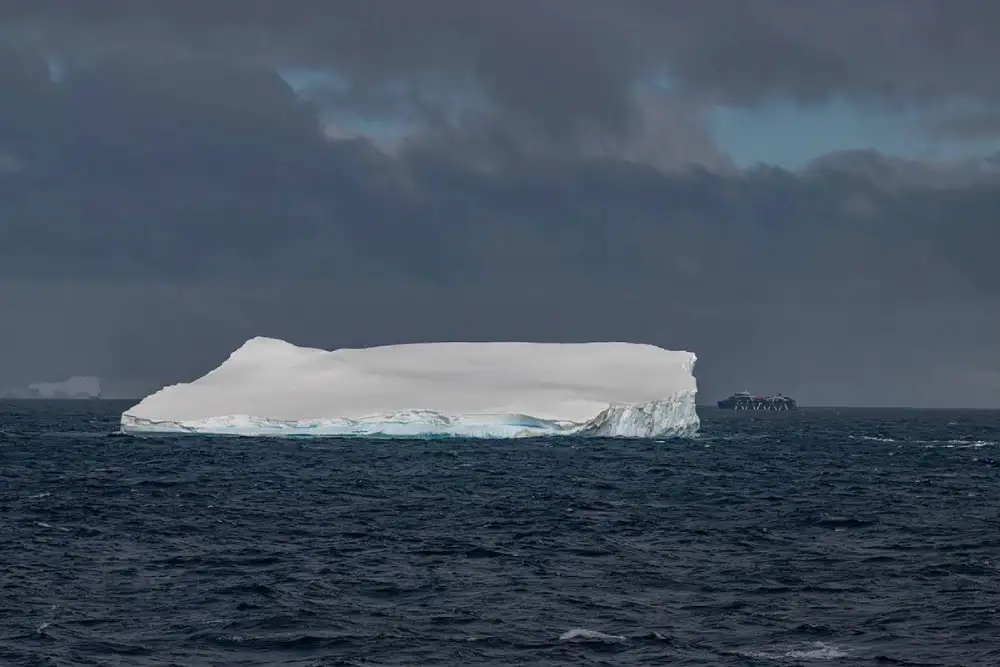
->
[121, 338, 699, 438]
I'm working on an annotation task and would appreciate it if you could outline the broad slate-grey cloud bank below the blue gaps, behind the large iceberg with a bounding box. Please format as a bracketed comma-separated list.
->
[0, 43, 1000, 404]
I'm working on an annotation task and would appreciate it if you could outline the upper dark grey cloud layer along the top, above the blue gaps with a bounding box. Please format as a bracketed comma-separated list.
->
[0, 0, 1000, 137]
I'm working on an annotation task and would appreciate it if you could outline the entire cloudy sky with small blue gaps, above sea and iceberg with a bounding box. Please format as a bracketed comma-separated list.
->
[0, 0, 1000, 407]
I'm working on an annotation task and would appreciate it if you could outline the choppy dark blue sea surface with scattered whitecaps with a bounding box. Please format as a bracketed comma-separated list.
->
[0, 401, 1000, 667]
